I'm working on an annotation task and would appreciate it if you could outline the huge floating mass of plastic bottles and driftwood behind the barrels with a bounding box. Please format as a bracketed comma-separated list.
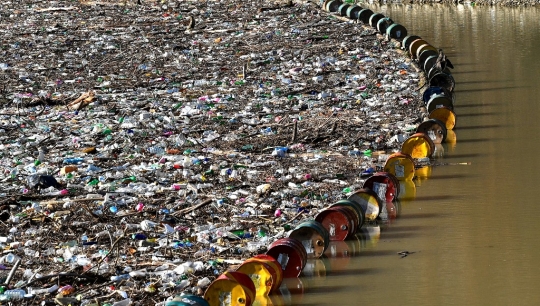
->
[0, 0, 426, 305]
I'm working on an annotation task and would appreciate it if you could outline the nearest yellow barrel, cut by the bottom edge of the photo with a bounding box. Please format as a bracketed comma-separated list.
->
[204, 271, 255, 306]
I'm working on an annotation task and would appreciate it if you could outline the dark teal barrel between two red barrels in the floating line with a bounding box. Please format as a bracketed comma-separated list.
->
[289, 220, 330, 258]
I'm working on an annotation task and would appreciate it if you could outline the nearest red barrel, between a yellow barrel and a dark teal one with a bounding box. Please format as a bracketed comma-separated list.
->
[266, 238, 307, 278]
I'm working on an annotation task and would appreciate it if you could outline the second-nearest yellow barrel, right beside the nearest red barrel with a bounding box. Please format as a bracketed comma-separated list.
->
[236, 255, 283, 295]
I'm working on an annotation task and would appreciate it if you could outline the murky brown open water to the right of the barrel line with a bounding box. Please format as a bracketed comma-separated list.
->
[282, 5, 540, 305]
